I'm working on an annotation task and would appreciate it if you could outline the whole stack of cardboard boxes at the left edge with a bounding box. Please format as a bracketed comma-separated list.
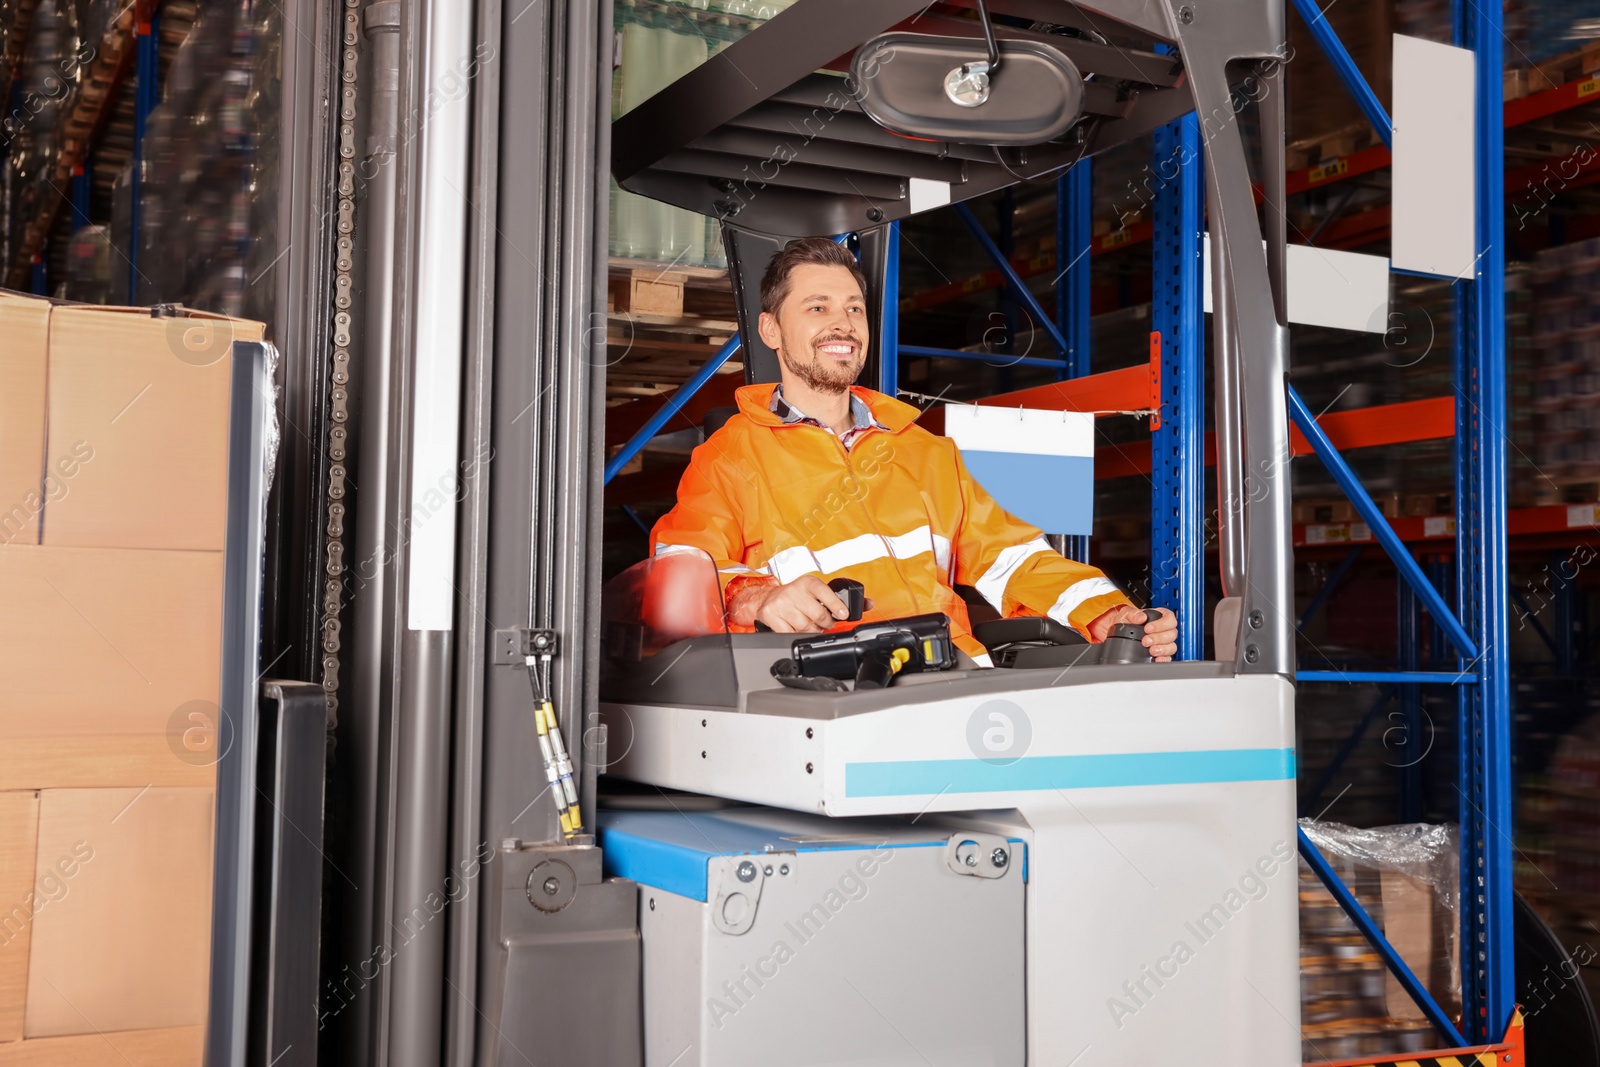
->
[0, 293, 262, 1067]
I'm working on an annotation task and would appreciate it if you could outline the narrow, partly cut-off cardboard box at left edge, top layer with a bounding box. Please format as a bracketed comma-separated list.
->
[0, 293, 50, 544]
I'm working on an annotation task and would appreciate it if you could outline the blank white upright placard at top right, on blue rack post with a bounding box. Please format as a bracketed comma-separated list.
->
[1389, 34, 1472, 278]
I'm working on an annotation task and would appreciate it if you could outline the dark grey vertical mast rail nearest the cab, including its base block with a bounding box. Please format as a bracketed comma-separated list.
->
[446, 0, 640, 1065]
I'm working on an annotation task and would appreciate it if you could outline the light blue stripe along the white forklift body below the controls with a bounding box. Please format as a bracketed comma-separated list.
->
[845, 749, 1294, 797]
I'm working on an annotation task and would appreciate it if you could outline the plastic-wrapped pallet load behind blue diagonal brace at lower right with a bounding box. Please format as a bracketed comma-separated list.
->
[1299, 819, 1461, 1064]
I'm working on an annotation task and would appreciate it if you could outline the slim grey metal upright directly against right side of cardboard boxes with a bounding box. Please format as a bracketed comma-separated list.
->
[205, 341, 272, 1067]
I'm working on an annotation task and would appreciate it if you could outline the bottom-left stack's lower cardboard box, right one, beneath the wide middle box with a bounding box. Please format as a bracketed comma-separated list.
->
[24, 789, 213, 1036]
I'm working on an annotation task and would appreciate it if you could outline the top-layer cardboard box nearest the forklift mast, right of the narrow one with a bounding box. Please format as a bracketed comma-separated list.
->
[42, 306, 262, 550]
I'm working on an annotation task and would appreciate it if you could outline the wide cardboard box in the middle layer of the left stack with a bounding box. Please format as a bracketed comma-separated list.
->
[0, 545, 222, 739]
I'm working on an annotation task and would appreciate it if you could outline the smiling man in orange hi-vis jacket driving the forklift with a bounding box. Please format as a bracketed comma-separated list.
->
[651, 237, 1178, 665]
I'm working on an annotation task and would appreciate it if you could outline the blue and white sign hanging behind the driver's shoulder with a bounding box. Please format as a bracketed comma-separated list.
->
[944, 403, 1094, 534]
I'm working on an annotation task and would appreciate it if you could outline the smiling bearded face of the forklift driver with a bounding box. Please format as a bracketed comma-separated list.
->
[760, 264, 870, 394]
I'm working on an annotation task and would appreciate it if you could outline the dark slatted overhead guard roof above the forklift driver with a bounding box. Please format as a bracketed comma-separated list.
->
[614, 0, 1192, 234]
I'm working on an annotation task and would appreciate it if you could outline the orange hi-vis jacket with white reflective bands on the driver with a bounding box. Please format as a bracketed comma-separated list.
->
[651, 384, 1130, 665]
